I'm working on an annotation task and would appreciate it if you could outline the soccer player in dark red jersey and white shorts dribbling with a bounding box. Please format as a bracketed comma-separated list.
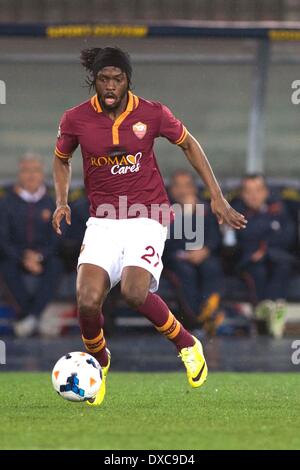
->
[53, 47, 246, 406]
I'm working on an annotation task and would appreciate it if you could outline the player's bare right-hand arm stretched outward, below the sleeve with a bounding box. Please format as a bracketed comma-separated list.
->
[178, 133, 247, 230]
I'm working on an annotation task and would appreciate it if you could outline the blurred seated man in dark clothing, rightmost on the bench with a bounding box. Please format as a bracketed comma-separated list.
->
[234, 174, 296, 336]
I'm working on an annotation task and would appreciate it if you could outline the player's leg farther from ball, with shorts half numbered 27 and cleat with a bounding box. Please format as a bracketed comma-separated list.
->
[121, 219, 207, 387]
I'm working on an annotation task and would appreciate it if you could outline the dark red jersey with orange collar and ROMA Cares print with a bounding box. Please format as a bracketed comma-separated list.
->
[55, 91, 187, 221]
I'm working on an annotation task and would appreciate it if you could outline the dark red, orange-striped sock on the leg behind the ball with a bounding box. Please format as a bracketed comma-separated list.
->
[79, 312, 108, 367]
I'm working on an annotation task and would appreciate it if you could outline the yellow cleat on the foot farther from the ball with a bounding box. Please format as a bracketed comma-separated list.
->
[178, 336, 208, 388]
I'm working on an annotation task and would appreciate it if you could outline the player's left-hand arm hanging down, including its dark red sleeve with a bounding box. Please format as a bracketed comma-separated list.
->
[52, 112, 78, 235]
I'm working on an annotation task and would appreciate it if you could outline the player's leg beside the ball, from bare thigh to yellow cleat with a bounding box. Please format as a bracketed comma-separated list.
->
[77, 263, 110, 406]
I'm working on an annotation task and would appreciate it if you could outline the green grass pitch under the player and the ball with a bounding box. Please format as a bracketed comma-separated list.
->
[0, 372, 300, 450]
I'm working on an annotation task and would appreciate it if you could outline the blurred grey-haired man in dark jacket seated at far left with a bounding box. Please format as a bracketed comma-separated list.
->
[0, 154, 61, 336]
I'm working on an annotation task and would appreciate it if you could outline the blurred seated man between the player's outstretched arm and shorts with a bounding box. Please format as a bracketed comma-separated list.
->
[164, 170, 223, 323]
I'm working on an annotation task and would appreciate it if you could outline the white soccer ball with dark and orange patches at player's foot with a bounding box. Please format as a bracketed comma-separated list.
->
[52, 352, 102, 401]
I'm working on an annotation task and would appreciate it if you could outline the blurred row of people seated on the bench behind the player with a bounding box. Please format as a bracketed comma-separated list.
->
[0, 153, 300, 337]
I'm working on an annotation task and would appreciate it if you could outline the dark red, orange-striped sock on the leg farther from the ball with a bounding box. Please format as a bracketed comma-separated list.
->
[138, 292, 195, 351]
